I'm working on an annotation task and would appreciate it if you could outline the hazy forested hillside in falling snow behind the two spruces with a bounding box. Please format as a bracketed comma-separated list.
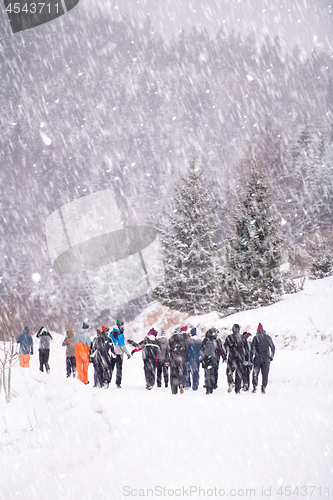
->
[0, 10, 333, 324]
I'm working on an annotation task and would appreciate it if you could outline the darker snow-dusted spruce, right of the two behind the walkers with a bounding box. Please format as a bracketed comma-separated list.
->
[222, 162, 282, 310]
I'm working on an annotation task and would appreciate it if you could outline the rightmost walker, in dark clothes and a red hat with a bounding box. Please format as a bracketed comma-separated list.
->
[251, 323, 275, 393]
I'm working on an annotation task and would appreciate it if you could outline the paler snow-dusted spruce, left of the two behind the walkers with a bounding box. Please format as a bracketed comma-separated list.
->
[152, 155, 217, 313]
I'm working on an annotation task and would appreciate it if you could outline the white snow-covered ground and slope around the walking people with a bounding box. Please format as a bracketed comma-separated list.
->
[0, 277, 333, 500]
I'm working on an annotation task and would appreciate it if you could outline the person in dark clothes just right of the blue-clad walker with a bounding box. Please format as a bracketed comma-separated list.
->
[200, 327, 225, 394]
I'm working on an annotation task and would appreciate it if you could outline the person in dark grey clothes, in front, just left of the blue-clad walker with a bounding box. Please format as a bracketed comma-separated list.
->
[166, 327, 188, 394]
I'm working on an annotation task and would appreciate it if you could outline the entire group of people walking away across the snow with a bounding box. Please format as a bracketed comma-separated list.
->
[16, 320, 275, 394]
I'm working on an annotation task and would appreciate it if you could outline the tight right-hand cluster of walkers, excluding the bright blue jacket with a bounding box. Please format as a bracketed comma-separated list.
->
[127, 323, 275, 394]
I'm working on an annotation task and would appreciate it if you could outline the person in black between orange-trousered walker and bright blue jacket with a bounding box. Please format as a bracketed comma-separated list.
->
[90, 325, 116, 388]
